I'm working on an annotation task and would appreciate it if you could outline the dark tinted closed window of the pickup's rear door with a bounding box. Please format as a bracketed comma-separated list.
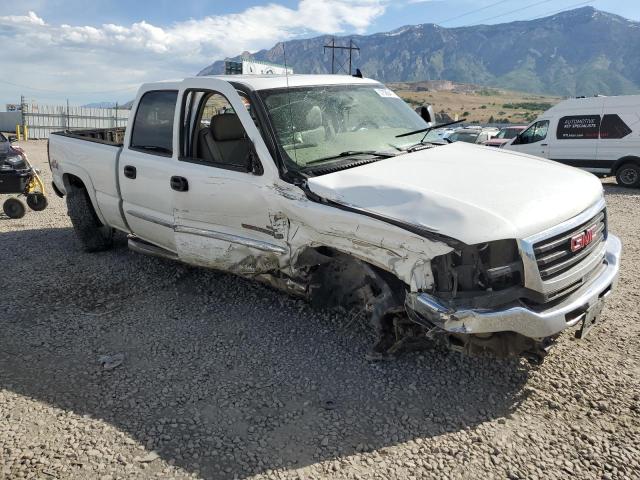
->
[130, 90, 178, 156]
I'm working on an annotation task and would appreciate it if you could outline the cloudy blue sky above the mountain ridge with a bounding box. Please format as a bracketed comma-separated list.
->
[0, 0, 640, 107]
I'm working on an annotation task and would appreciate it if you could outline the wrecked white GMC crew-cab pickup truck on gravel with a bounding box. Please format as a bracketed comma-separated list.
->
[49, 75, 621, 360]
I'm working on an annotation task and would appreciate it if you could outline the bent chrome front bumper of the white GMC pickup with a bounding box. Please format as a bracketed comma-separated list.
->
[406, 234, 622, 339]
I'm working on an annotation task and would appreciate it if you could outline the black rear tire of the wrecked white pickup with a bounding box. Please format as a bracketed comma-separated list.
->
[67, 185, 113, 252]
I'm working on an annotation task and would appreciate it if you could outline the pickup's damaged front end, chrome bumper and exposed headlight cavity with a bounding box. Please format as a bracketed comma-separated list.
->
[405, 235, 621, 362]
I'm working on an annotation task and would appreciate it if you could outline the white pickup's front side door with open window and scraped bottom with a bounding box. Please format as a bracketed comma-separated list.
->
[173, 78, 288, 275]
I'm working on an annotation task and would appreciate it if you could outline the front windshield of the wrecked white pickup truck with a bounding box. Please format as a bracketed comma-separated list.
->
[261, 84, 427, 168]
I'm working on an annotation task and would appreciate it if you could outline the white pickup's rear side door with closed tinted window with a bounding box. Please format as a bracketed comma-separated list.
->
[118, 90, 178, 252]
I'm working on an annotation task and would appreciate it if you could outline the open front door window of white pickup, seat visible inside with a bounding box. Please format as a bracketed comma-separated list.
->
[182, 92, 255, 172]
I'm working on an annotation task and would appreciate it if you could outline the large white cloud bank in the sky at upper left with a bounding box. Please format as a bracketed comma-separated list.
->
[0, 0, 388, 102]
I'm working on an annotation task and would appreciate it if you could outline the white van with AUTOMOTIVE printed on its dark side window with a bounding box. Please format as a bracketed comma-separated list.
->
[504, 95, 640, 187]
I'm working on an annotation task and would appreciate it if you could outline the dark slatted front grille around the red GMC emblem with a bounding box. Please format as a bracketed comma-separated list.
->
[533, 210, 607, 281]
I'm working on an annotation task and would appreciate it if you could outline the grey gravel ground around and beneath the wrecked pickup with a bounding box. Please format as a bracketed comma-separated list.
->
[0, 141, 640, 480]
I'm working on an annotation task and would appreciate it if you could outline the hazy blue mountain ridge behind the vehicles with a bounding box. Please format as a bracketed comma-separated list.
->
[199, 7, 640, 95]
